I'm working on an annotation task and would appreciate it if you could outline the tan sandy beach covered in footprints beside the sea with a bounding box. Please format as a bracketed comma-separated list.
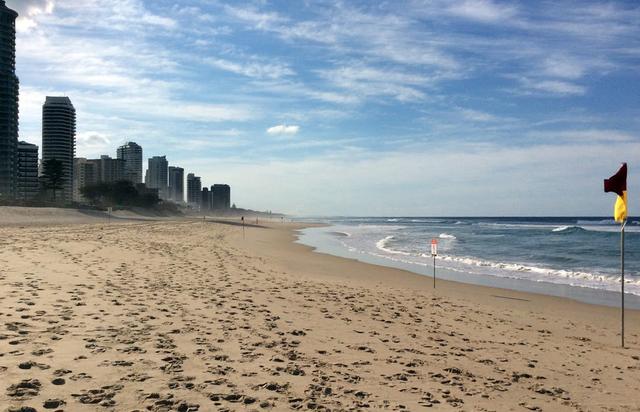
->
[0, 217, 640, 411]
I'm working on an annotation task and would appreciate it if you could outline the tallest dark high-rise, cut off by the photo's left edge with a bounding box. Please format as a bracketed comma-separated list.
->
[0, 0, 19, 199]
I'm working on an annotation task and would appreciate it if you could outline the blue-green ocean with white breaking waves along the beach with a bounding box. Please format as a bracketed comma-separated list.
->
[299, 217, 640, 306]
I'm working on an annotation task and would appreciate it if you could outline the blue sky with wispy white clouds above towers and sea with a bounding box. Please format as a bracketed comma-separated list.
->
[7, 0, 640, 216]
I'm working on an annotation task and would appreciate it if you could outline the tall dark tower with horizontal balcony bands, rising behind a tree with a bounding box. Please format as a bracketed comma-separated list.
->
[42, 96, 76, 202]
